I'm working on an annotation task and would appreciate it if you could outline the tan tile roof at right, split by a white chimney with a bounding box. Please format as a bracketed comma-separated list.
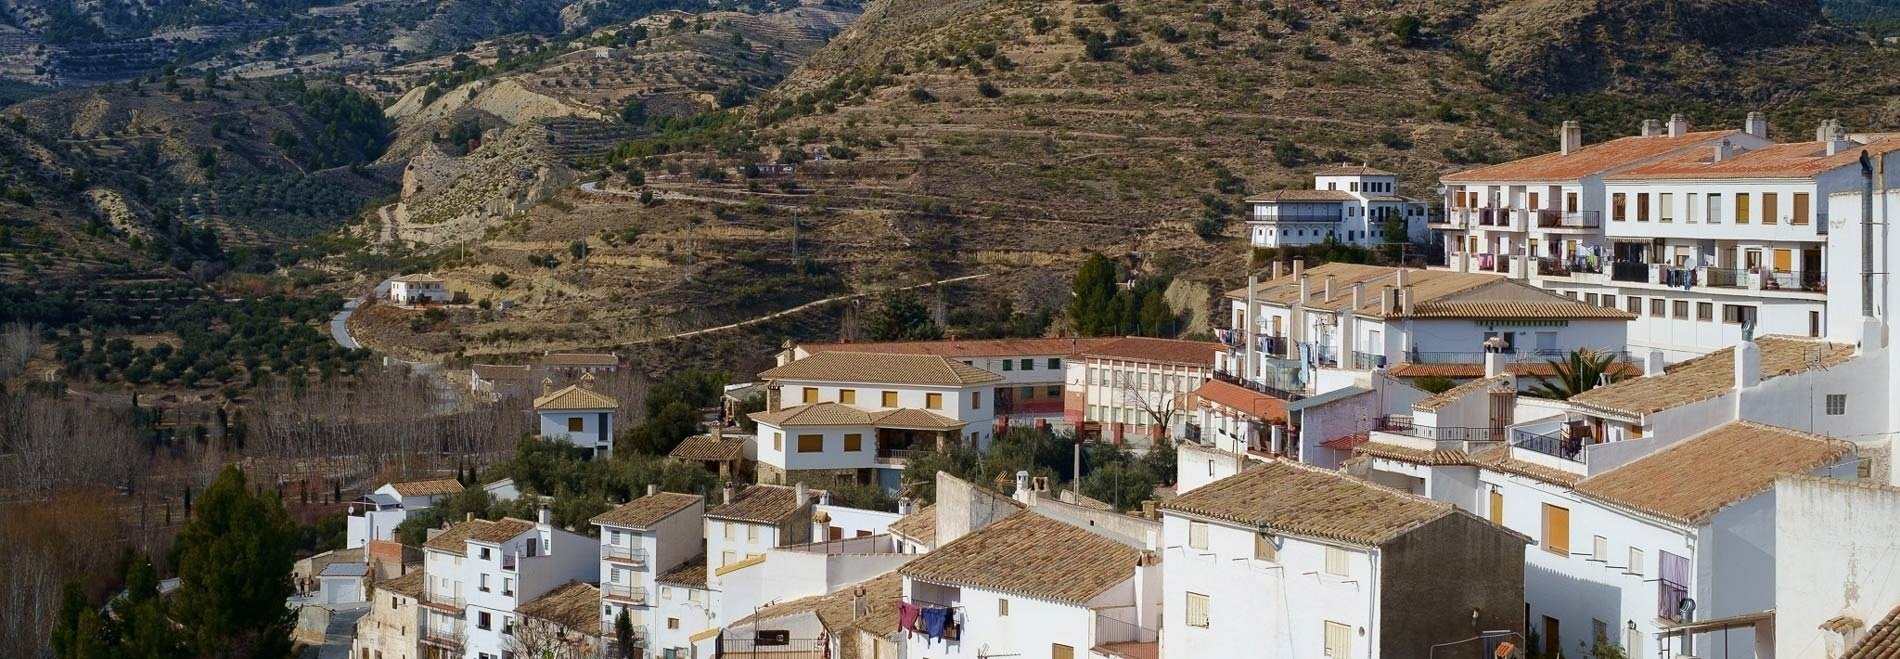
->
[1569, 334, 1854, 416]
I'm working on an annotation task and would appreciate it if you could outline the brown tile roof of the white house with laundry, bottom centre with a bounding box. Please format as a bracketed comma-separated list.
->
[897, 512, 1132, 604]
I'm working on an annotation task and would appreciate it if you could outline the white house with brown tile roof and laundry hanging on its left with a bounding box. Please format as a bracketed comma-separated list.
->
[899, 507, 1161, 659]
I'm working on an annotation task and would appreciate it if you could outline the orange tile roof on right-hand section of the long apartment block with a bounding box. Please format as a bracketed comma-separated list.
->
[1604, 139, 1900, 180]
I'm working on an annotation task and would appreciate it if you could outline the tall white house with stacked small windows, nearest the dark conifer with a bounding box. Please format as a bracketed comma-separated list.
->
[422, 509, 600, 659]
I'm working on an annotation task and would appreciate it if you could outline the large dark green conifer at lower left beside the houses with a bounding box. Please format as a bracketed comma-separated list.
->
[171, 465, 296, 659]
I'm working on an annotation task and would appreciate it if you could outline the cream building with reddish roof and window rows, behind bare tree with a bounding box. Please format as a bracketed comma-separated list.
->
[1064, 336, 1226, 444]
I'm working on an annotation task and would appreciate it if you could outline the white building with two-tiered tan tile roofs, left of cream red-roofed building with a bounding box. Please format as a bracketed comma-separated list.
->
[747, 351, 1003, 490]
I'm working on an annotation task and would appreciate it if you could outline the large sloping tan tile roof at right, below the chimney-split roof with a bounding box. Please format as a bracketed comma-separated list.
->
[1575, 422, 1854, 524]
